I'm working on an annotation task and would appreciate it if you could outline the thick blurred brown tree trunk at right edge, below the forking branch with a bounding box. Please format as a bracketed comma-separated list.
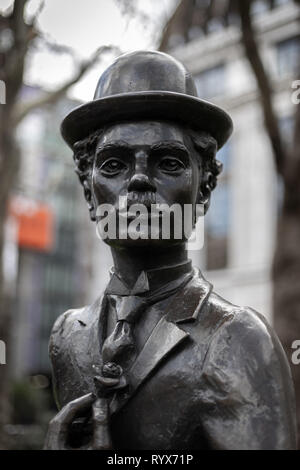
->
[273, 104, 300, 449]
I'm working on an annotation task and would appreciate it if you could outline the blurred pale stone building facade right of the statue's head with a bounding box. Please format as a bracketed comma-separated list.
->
[164, 0, 300, 319]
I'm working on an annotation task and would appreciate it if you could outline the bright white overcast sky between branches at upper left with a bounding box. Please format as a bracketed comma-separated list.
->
[0, 0, 177, 101]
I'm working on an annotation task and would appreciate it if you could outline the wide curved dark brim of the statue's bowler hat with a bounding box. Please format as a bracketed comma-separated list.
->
[61, 91, 233, 149]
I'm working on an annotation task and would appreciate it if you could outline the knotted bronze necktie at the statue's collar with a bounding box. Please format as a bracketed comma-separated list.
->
[102, 295, 147, 369]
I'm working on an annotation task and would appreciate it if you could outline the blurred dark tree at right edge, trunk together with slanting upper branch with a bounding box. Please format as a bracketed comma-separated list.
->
[237, 0, 300, 447]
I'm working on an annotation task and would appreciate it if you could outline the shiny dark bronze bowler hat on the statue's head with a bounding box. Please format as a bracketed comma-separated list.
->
[61, 51, 232, 148]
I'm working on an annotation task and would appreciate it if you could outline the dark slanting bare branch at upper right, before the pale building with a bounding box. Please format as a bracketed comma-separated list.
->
[236, 0, 286, 175]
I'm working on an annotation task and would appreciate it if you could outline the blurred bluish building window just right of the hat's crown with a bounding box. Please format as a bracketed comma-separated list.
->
[195, 64, 226, 99]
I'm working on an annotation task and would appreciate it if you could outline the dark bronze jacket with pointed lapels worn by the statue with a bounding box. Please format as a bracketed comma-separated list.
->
[49, 270, 296, 450]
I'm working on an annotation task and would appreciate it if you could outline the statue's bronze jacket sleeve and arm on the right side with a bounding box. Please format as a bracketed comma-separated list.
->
[201, 308, 296, 449]
